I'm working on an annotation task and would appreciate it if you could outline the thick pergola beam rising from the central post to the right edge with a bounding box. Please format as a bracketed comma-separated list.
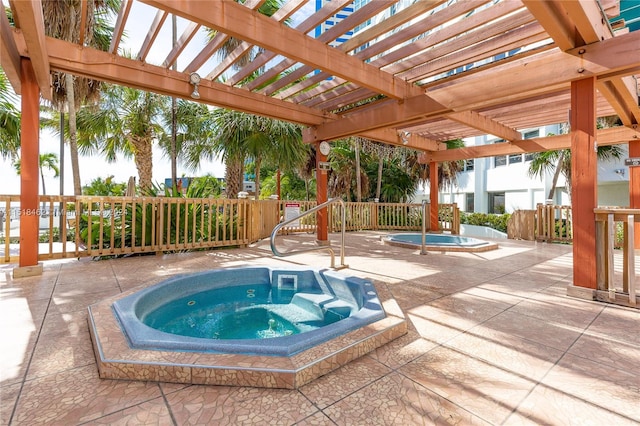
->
[307, 31, 640, 142]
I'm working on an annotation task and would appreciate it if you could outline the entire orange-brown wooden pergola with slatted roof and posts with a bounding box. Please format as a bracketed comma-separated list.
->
[0, 0, 640, 289]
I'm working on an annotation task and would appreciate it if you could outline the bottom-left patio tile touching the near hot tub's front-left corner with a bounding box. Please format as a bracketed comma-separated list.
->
[14, 365, 161, 425]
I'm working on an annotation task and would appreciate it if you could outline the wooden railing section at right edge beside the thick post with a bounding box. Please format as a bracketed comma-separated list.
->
[594, 208, 640, 306]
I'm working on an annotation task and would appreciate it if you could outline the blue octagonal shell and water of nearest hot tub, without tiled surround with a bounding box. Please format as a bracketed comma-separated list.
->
[113, 267, 384, 356]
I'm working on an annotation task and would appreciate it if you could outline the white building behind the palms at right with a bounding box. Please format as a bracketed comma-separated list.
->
[416, 125, 629, 213]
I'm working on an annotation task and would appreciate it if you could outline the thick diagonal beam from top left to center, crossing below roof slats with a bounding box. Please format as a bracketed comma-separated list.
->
[141, 0, 421, 99]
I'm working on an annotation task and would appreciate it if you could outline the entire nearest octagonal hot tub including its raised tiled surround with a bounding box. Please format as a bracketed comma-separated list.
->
[88, 266, 407, 389]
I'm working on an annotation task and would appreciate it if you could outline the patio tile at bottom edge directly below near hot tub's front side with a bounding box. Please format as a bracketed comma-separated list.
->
[166, 386, 318, 425]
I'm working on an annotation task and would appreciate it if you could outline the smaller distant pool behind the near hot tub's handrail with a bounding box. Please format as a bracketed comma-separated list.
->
[382, 233, 498, 252]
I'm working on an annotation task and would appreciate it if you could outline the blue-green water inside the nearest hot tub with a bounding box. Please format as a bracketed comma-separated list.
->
[142, 284, 341, 339]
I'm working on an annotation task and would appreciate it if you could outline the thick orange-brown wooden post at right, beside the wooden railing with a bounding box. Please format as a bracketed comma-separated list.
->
[570, 77, 598, 289]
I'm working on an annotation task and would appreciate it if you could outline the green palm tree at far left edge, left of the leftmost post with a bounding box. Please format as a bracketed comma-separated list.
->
[0, 68, 20, 159]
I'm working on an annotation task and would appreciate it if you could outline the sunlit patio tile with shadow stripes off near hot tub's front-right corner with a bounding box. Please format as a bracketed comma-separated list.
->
[398, 347, 535, 424]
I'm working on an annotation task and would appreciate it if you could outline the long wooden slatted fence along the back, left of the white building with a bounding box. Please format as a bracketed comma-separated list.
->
[0, 195, 460, 263]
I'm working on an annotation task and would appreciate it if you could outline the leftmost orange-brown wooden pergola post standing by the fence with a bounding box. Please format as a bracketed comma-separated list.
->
[13, 58, 42, 277]
